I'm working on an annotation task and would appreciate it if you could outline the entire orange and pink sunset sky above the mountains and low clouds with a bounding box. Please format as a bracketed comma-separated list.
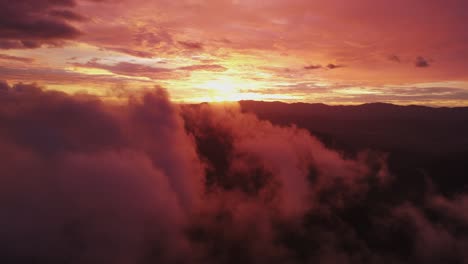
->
[0, 0, 468, 106]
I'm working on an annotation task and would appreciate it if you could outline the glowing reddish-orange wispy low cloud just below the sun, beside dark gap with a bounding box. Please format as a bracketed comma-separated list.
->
[181, 103, 386, 216]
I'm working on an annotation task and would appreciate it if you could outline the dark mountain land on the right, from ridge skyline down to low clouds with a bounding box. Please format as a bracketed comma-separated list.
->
[240, 101, 468, 193]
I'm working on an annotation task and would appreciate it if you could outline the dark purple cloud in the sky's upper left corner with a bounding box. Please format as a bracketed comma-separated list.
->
[0, 0, 81, 48]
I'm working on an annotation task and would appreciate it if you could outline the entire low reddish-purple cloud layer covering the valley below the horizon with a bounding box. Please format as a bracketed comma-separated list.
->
[0, 82, 468, 263]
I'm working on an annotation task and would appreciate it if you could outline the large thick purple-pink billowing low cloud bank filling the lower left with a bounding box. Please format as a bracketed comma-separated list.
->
[0, 84, 203, 263]
